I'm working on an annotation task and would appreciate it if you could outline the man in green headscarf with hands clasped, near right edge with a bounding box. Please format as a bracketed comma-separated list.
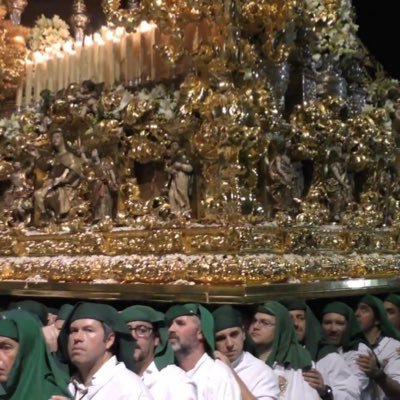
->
[355, 295, 400, 400]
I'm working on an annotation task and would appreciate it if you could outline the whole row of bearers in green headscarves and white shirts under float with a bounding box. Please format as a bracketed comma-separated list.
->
[0, 294, 400, 400]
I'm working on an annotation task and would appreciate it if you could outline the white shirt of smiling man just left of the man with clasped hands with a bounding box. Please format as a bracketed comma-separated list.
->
[316, 353, 360, 400]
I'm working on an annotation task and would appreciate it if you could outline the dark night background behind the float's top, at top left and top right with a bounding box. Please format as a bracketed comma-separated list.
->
[22, 0, 400, 79]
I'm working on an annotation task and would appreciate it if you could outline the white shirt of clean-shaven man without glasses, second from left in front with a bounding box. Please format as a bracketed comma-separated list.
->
[68, 356, 153, 400]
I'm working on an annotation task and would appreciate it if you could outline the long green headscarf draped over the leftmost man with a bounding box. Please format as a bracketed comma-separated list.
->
[0, 310, 71, 400]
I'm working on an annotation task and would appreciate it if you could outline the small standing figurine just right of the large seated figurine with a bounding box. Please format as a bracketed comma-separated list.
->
[82, 149, 119, 223]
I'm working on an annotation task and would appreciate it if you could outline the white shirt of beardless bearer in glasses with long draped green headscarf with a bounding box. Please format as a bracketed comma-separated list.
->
[272, 363, 321, 400]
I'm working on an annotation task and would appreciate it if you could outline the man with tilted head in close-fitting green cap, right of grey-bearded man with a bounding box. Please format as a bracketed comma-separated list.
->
[212, 305, 279, 400]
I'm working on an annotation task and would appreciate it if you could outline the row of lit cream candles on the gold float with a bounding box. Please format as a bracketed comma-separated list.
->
[16, 21, 157, 107]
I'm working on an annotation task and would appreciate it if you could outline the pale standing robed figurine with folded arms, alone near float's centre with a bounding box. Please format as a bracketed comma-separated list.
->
[165, 142, 193, 214]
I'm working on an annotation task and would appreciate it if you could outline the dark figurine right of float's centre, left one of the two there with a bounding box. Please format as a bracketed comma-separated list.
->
[266, 140, 304, 215]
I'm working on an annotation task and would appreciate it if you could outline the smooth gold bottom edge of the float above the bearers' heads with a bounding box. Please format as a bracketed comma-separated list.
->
[0, 278, 400, 304]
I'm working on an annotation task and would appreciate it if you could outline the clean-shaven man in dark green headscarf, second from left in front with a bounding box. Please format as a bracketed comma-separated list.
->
[54, 303, 152, 400]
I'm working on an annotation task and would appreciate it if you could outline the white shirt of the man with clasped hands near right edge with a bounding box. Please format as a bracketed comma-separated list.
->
[361, 337, 400, 400]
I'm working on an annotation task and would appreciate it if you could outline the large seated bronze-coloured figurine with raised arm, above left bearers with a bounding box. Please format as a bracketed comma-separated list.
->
[31, 129, 83, 225]
